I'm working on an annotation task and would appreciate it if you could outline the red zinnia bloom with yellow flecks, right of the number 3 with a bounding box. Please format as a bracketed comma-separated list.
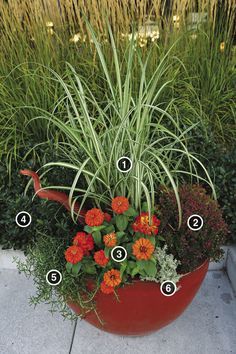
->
[132, 212, 161, 236]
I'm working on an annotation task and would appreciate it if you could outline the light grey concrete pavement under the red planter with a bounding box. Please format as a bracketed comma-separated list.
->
[0, 270, 236, 354]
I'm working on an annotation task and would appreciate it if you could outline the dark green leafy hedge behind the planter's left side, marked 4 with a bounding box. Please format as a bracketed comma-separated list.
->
[0, 150, 83, 251]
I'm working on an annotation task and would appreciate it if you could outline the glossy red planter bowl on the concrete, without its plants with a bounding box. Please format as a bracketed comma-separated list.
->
[69, 261, 209, 335]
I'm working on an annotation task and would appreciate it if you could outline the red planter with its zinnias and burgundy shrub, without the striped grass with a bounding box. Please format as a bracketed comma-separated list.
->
[16, 170, 227, 335]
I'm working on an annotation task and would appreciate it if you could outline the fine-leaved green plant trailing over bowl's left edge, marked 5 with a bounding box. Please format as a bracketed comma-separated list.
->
[16, 233, 94, 320]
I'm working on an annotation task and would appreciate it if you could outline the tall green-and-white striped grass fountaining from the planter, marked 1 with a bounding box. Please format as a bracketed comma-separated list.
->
[29, 23, 214, 224]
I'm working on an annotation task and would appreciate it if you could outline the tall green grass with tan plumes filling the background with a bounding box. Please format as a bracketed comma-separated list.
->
[0, 0, 236, 171]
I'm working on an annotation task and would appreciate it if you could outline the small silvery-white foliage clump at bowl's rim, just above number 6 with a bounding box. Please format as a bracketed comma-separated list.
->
[140, 245, 181, 284]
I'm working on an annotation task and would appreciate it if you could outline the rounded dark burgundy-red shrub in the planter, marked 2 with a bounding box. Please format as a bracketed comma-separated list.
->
[159, 185, 228, 272]
